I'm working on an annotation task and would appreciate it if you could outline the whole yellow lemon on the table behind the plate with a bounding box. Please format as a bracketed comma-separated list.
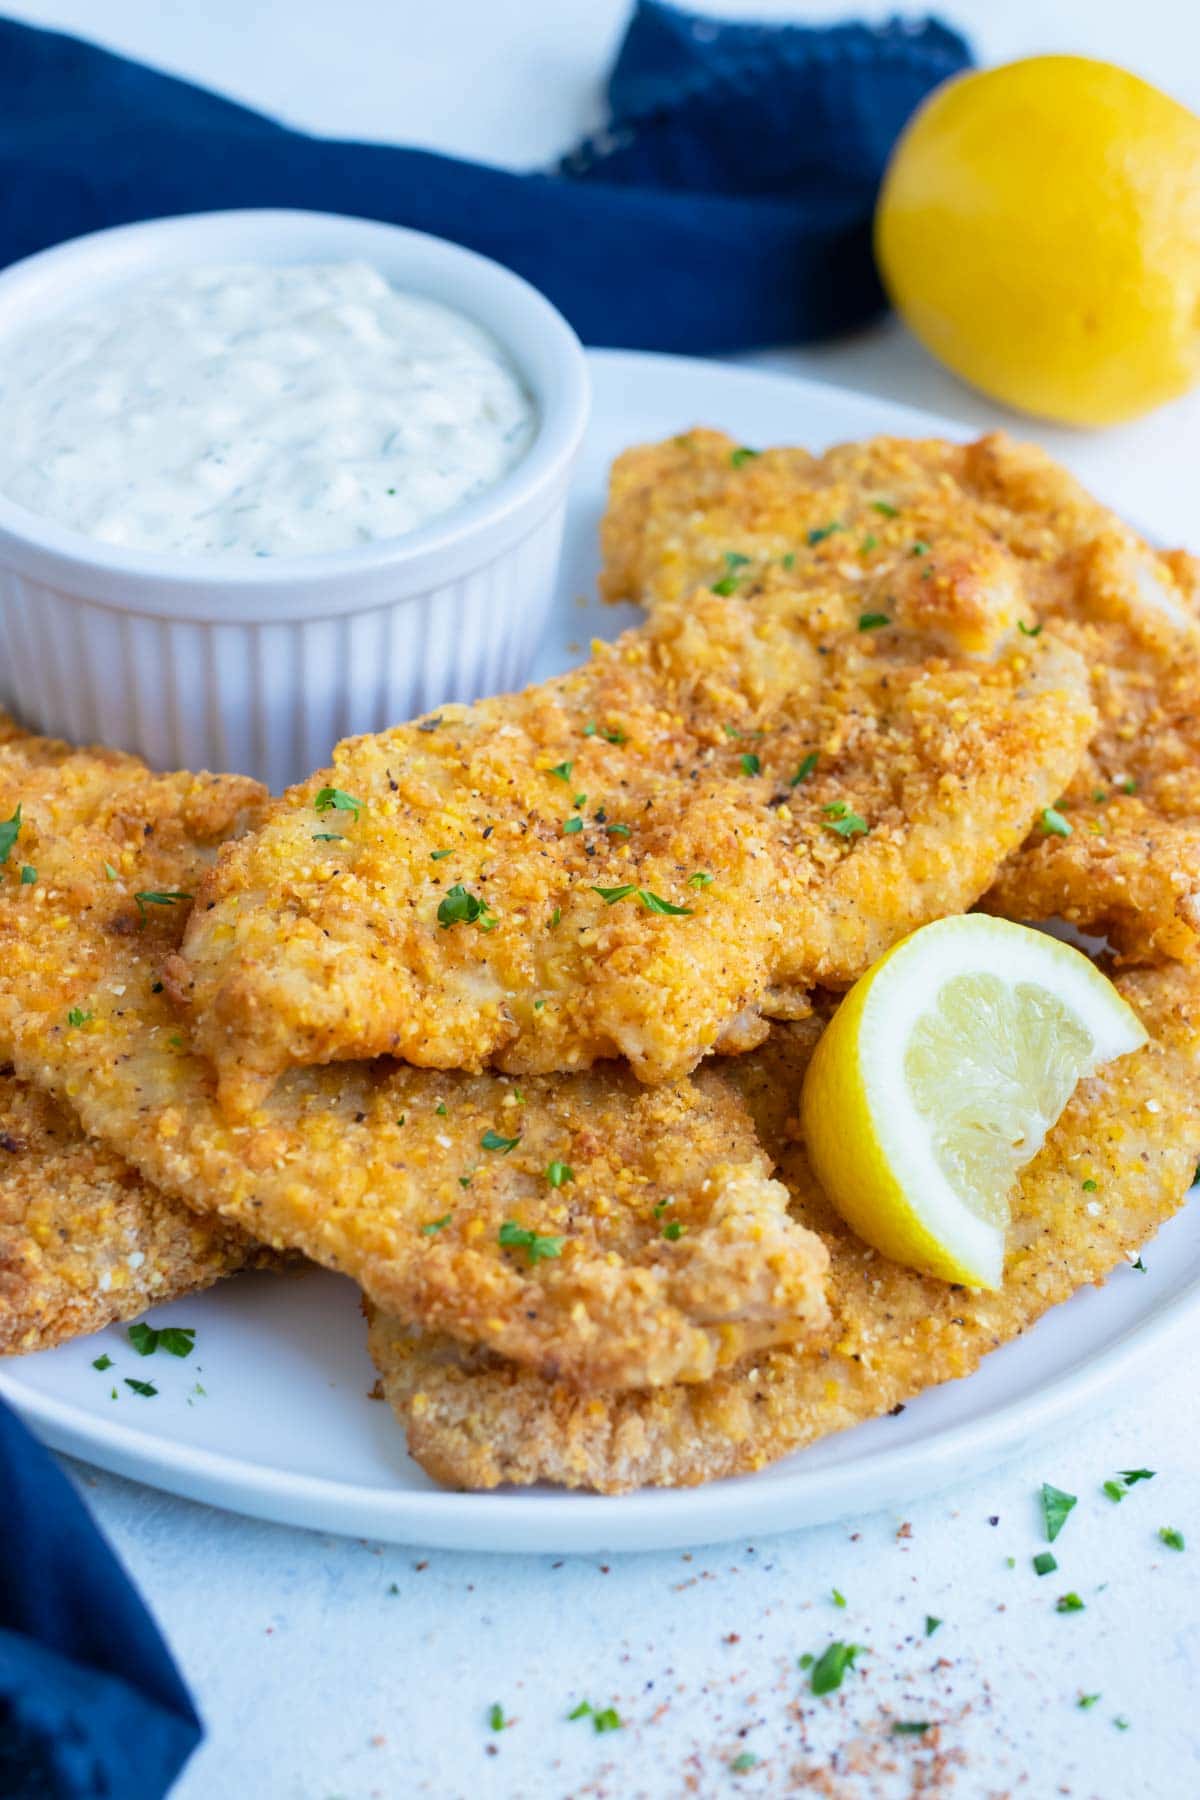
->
[874, 56, 1200, 425]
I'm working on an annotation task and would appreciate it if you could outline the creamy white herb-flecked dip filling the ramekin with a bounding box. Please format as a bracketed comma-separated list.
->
[0, 263, 536, 556]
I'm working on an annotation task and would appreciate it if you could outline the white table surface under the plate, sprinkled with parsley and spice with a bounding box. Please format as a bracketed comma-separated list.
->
[7, 0, 1200, 1800]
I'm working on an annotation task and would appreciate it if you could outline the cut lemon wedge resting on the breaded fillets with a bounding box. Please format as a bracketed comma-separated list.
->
[801, 913, 1146, 1287]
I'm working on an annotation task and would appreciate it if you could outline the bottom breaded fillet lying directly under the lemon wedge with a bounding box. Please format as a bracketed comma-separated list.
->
[371, 967, 1200, 1494]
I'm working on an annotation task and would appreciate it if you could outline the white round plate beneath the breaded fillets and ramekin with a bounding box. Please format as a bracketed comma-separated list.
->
[0, 353, 1200, 1552]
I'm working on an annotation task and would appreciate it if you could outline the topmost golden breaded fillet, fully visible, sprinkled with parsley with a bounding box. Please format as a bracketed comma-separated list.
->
[167, 563, 1094, 1111]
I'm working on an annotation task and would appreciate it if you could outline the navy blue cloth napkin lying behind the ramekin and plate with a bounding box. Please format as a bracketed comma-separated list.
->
[0, 0, 970, 353]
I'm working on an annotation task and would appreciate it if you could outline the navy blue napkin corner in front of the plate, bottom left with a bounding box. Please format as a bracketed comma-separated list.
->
[0, 1404, 200, 1800]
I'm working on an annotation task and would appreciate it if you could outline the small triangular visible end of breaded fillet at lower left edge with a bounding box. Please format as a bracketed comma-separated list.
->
[0, 1069, 263, 1355]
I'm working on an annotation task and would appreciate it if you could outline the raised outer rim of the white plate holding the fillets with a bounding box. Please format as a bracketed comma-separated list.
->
[0, 349, 1200, 1555]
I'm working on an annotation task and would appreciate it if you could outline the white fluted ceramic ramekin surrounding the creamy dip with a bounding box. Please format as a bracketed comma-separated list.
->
[0, 212, 588, 788]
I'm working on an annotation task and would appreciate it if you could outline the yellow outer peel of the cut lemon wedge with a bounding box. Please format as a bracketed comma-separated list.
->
[801, 940, 1004, 1289]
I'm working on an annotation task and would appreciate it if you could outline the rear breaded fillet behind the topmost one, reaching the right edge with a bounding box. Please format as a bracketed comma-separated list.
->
[603, 430, 1200, 961]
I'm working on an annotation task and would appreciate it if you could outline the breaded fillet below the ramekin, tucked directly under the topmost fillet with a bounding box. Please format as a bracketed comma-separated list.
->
[0, 723, 826, 1388]
